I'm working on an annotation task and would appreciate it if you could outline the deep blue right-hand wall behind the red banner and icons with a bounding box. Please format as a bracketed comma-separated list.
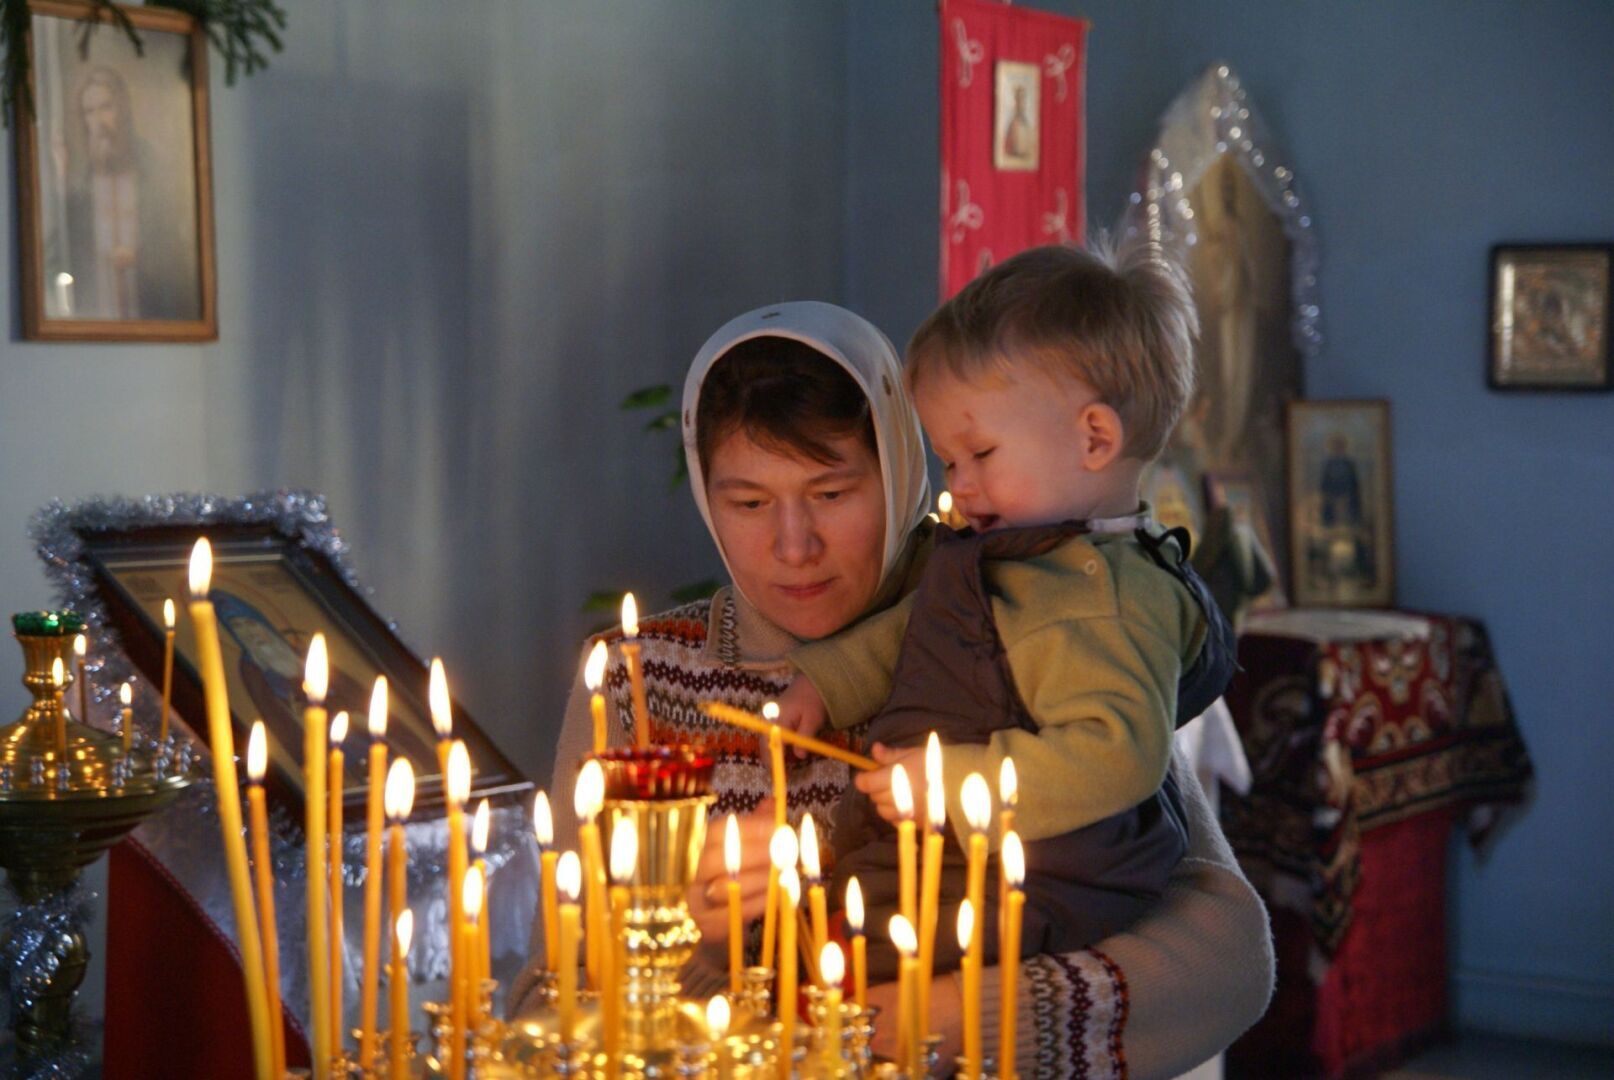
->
[846, 0, 1614, 1041]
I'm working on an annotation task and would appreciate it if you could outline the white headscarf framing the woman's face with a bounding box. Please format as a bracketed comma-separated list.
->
[683, 300, 930, 599]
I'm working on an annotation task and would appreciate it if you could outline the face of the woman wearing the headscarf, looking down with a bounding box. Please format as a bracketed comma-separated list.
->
[705, 431, 886, 638]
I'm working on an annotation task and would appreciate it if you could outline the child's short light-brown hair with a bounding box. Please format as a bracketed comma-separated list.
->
[907, 239, 1199, 462]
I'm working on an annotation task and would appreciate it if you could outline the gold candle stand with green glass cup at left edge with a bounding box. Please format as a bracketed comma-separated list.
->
[0, 612, 192, 1065]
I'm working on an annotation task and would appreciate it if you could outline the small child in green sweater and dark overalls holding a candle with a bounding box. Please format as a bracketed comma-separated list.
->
[780, 237, 1233, 977]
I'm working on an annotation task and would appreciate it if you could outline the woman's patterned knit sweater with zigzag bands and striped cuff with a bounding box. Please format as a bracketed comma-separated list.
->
[508, 588, 1272, 1078]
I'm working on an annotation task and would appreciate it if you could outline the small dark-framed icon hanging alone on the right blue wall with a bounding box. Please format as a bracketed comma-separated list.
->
[1485, 244, 1614, 391]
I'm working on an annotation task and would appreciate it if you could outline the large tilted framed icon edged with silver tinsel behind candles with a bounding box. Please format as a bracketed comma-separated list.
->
[76, 523, 533, 820]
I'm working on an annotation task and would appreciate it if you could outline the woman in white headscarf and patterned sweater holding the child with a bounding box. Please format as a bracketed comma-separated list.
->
[512, 302, 1272, 1077]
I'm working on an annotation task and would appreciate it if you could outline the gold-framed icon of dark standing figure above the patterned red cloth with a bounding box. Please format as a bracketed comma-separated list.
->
[1285, 399, 1394, 607]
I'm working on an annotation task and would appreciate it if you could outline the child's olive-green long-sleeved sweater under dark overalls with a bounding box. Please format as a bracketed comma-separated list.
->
[791, 533, 1206, 844]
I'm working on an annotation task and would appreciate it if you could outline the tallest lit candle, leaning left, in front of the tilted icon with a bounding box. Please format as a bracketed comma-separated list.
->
[190, 538, 278, 1080]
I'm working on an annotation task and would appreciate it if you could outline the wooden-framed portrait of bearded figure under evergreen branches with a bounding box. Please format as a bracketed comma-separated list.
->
[13, 0, 218, 342]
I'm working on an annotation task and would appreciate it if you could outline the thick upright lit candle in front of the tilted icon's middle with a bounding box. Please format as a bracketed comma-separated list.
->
[303, 633, 331, 1080]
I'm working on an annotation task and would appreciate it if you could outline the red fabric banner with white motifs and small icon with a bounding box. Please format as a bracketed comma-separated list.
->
[941, 0, 1088, 300]
